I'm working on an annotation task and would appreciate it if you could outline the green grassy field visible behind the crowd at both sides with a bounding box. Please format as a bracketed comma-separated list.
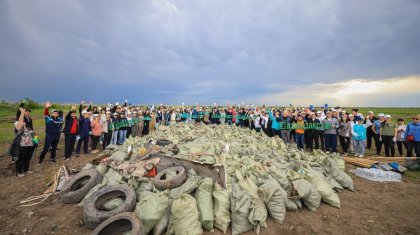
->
[0, 103, 420, 147]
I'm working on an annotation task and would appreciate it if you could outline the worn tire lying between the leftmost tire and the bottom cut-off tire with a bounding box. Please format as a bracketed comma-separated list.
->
[83, 185, 136, 229]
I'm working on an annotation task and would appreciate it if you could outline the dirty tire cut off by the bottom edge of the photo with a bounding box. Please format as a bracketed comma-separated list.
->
[92, 212, 144, 235]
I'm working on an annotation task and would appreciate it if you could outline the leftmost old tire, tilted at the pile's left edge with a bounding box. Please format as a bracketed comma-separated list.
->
[60, 168, 102, 203]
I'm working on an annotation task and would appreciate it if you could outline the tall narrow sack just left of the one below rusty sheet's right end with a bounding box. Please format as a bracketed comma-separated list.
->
[195, 178, 214, 232]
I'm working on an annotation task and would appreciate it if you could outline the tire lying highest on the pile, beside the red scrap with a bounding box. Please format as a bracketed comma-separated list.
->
[153, 166, 187, 191]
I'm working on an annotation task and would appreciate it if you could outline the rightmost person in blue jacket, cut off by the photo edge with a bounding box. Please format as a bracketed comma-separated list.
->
[404, 114, 420, 157]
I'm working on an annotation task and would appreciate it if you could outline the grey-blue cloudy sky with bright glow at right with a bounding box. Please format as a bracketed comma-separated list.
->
[0, 0, 420, 107]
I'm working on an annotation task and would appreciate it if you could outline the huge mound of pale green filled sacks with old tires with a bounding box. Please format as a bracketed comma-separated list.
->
[60, 123, 354, 235]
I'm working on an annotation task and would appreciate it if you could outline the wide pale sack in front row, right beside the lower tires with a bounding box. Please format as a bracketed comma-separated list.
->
[135, 191, 169, 234]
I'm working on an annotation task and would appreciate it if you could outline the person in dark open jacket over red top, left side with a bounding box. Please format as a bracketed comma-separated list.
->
[63, 105, 79, 161]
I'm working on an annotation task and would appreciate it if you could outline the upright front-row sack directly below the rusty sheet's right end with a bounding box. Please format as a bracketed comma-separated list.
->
[213, 184, 230, 233]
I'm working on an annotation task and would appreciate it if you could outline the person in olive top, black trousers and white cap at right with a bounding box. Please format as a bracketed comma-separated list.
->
[379, 114, 397, 157]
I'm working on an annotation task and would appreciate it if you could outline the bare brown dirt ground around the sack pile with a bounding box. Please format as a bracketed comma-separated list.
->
[0, 146, 420, 235]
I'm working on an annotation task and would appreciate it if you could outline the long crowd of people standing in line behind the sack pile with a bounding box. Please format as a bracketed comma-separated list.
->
[9, 101, 420, 176]
